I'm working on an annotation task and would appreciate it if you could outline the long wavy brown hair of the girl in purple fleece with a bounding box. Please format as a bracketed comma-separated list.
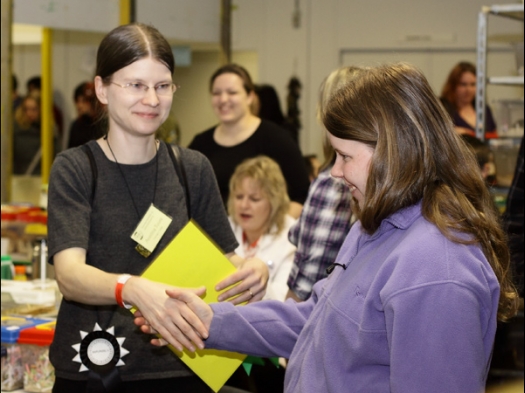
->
[322, 63, 518, 320]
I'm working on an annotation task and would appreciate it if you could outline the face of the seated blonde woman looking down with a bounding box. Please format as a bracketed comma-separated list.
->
[233, 177, 272, 239]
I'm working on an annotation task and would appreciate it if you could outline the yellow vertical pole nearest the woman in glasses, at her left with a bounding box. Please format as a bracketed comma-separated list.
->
[40, 27, 53, 184]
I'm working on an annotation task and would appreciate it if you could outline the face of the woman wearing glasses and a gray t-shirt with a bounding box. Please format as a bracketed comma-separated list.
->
[95, 57, 173, 135]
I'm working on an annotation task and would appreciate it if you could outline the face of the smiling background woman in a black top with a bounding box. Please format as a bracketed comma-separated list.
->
[211, 73, 253, 123]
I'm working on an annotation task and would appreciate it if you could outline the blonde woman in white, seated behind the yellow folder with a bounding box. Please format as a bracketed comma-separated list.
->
[228, 156, 295, 301]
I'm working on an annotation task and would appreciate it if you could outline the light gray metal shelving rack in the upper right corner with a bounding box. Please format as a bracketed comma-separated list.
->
[476, 4, 524, 140]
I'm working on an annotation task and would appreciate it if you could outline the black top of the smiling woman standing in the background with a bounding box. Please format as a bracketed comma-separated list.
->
[188, 119, 310, 204]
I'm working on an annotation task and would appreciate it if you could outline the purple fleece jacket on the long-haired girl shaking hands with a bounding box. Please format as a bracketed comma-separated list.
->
[206, 204, 499, 393]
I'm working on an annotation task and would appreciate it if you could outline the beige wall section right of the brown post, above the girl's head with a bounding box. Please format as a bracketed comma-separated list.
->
[233, 0, 523, 155]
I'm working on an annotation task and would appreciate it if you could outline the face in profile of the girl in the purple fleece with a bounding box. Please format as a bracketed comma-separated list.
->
[328, 133, 374, 207]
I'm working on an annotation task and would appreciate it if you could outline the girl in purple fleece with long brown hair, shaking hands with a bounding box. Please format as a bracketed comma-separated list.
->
[136, 63, 518, 393]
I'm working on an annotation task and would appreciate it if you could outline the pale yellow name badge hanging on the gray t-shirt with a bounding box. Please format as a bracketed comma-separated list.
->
[131, 204, 172, 258]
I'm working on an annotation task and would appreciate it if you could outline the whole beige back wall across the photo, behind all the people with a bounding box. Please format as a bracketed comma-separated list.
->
[10, 0, 523, 156]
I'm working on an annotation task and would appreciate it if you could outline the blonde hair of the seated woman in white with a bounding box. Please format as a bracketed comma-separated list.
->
[228, 156, 290, 232]
